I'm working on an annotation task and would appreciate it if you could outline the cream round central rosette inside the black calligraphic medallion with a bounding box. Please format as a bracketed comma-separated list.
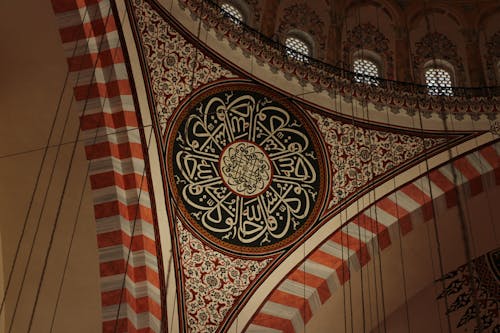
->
[219, 141, 272, 197]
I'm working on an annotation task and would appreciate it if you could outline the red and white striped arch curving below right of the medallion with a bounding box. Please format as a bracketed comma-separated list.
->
[246, 143, 500, 333]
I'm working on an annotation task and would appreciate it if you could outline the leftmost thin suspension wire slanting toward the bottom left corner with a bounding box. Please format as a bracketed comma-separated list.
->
[0, 4, 94, 314]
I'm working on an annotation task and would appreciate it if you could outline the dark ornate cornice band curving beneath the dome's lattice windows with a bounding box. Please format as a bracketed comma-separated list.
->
[178, 0, 500, 120]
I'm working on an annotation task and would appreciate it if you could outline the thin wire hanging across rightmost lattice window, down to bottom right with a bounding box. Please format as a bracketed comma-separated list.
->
[425, 3, 483, 332]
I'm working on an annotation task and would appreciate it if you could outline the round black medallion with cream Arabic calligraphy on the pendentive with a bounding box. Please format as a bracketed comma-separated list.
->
[166, 84, 324, 255]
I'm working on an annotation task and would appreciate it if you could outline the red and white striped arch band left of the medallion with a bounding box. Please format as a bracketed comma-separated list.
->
[52, 0, 162, 332]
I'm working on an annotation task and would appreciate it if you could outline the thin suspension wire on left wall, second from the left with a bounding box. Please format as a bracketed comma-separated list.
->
[19, 4, 124, 332]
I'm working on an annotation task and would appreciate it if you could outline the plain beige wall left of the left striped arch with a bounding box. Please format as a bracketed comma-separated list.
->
[0, 0, 101, 333]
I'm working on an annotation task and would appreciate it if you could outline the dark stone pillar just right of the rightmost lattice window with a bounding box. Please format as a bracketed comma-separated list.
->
[462, 29, 486, 87]
